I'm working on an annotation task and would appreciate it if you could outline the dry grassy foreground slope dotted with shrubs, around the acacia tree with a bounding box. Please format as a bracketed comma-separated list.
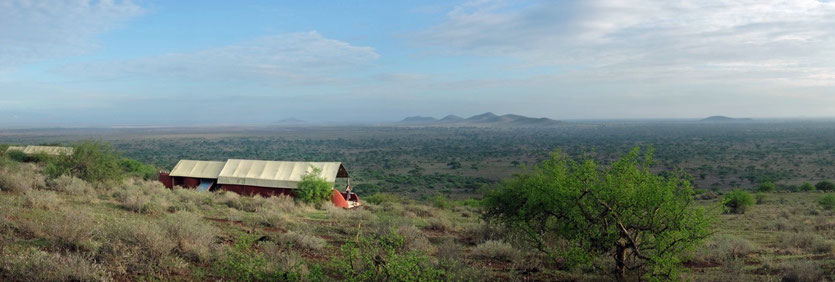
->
[0, 160, 835, 281]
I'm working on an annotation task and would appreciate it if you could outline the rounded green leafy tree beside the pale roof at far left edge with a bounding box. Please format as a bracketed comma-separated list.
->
[44, 141, 125, 182]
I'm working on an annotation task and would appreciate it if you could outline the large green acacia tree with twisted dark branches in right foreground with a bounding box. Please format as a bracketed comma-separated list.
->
[485, 147, 715, 279]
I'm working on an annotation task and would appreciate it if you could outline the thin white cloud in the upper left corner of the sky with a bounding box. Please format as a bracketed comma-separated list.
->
[0, 0, 142, 71]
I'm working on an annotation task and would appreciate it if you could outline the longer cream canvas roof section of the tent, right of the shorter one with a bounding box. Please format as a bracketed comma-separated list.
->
[217, 159, 350, 189]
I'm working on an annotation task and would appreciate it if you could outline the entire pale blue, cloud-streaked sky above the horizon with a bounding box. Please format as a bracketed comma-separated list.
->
[0, 0, 835, 127]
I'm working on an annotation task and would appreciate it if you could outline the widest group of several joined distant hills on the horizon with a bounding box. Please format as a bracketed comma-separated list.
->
[400, 112, 560, 127]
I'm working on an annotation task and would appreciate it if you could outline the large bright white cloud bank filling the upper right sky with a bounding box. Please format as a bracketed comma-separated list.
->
[416, 0, 835, 86]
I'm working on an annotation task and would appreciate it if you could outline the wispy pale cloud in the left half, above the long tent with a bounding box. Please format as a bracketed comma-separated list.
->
[57, 31, 379, 84]
